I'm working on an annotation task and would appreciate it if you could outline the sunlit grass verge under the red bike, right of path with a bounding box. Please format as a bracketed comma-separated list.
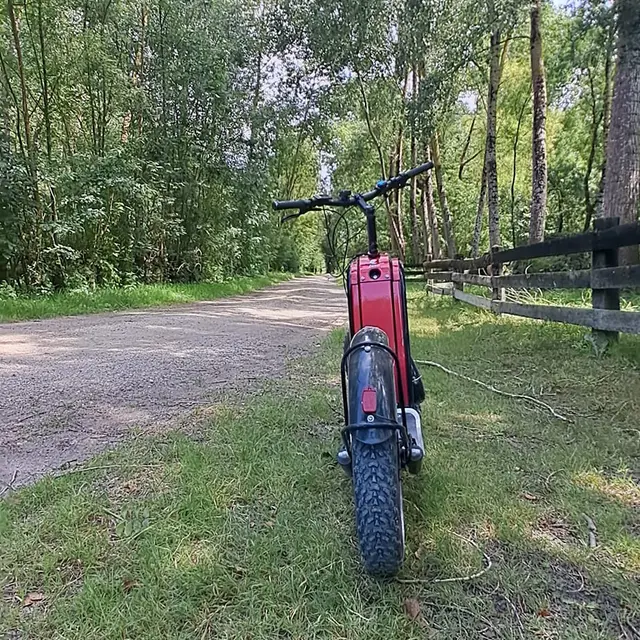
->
[0, 293, 640, 640]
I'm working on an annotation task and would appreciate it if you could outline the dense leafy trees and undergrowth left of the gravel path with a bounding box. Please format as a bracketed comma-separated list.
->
[0, 0, 322, 293]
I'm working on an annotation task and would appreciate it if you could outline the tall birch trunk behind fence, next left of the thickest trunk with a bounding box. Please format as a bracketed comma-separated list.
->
[529, 0, 547, 244]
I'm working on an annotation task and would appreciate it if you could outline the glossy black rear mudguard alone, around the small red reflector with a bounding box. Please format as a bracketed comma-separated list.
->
[345, 327, 399, 444]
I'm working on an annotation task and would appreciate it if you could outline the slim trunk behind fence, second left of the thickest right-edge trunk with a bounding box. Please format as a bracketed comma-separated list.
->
[487, 29, 500, 247]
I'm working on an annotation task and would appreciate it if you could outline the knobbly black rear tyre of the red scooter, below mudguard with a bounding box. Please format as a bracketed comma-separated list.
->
[352, 437, 404, 577]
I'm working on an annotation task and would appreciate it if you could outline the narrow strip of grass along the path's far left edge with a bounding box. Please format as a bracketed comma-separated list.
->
[0, 273, 291, 322]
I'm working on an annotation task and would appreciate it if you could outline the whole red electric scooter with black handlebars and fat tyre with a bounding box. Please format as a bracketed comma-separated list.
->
[273, 162, 433, 576]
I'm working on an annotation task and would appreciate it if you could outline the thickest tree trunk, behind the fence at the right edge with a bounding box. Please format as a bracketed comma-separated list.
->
[603, 0, 640, 264]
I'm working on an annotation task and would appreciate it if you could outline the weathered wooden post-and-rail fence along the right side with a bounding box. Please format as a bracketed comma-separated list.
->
[423, 218, 640, 338]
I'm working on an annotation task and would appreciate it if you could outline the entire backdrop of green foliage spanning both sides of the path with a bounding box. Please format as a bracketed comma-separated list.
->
[0, 0, 614, 292]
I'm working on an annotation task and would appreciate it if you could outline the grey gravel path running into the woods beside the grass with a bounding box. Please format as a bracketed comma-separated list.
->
[0, 276, 346, 490]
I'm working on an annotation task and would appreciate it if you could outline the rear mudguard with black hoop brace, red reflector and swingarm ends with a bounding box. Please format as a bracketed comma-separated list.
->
[338, 327, 424, 474]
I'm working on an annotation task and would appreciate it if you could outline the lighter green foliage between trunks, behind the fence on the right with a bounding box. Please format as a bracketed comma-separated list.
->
[292, 0, 613, 260]
